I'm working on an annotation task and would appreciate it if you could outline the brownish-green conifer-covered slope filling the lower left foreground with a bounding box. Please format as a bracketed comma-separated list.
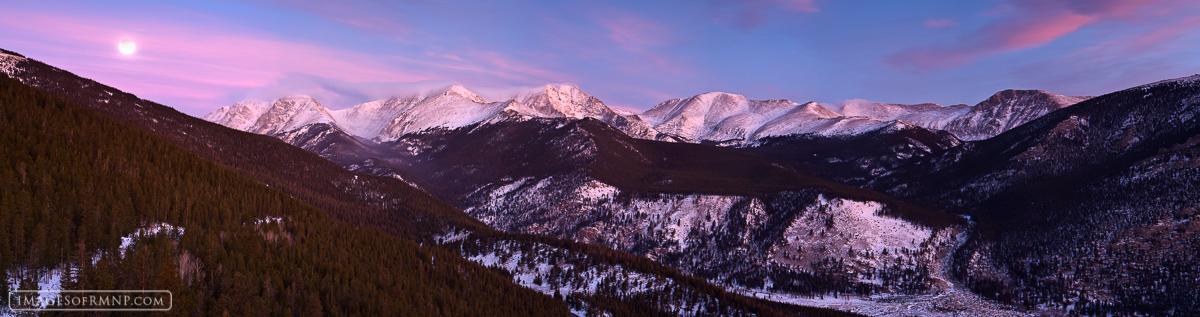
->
[0, 72, 568, 316]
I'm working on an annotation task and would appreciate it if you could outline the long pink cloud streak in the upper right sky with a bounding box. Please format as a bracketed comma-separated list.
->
[884, 0, 1183, 68]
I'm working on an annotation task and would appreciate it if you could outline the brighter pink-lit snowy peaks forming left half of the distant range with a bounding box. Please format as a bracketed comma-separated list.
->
[204, 84, 662, 142]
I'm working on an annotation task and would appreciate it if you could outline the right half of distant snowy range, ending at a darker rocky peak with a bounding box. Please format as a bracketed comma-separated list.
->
[641, 90, 1087, 145]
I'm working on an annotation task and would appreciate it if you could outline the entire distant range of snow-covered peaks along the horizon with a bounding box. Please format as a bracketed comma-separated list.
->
[204, 84, 1087, 145]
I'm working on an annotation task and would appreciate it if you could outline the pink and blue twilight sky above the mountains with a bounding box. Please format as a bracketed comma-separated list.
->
[0, 0, 1200, 115]
